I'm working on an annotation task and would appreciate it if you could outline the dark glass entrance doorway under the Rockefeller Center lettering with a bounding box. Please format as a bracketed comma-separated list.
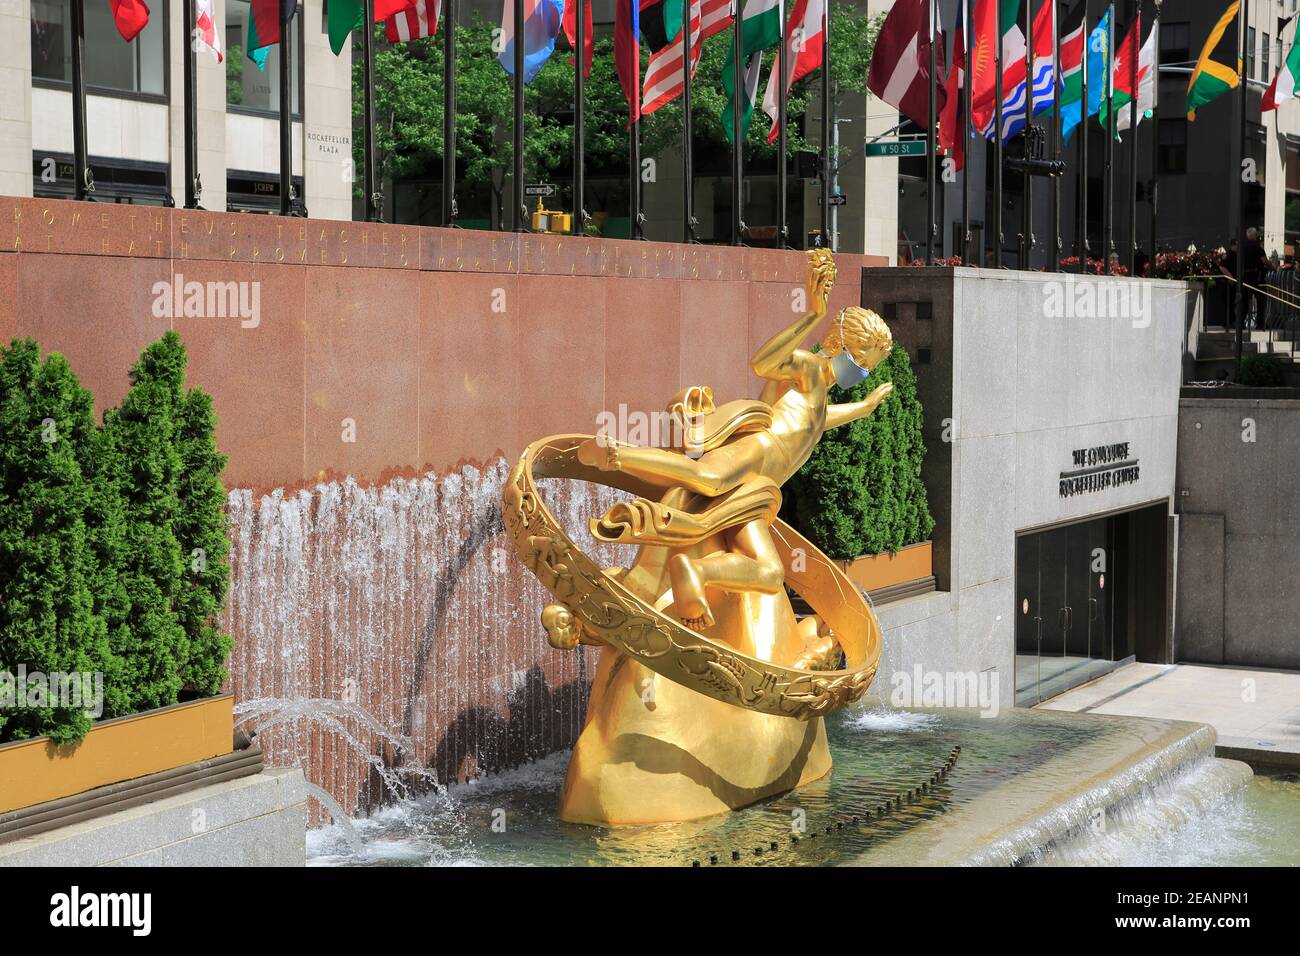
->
[1015, 503, 1167, 706]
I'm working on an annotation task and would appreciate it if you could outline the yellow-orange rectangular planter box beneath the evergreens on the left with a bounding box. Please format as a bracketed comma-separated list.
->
[0, 693, 234, 813]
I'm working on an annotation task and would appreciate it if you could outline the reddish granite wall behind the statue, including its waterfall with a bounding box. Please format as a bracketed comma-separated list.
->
[0, 198, 879, 819]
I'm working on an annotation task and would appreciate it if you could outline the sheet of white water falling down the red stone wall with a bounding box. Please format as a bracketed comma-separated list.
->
[226, 459, 628, 821]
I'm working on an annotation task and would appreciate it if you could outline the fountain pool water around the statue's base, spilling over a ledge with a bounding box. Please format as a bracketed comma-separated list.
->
[308, 708, 1300, 866]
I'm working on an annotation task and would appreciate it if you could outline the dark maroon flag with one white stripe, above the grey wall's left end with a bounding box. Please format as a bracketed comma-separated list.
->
[867, 0, 946, 129]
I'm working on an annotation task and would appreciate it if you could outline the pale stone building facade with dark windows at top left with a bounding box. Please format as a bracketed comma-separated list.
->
[0, 0, 352, 219]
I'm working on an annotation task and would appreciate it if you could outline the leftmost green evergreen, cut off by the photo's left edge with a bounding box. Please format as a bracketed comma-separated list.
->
[0, 339, 111, 743]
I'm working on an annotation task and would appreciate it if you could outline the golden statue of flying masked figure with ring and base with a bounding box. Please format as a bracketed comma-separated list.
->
[503, 250, 893, 826]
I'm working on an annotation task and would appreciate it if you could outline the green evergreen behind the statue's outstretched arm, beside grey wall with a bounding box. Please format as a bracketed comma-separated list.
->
[781, 343, 935, 561]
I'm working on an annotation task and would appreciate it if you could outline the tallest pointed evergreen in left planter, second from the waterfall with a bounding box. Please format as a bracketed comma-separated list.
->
[103, 332, 190, 713]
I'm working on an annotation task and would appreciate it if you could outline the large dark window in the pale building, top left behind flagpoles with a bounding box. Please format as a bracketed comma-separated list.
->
[31, 0, 168, 96]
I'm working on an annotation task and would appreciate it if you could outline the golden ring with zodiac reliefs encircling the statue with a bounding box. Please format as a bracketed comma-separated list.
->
[502, 434, 881, 721]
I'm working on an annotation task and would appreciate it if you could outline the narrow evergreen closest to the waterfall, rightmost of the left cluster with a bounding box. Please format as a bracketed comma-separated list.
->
[176, 389, 234, 696]
